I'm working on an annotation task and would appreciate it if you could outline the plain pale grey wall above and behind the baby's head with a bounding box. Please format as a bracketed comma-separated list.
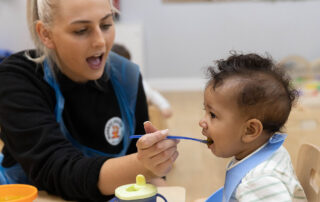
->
[121, 0, 320, 89]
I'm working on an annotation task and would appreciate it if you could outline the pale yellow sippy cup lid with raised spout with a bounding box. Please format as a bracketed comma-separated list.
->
[115, 174, 157, 200]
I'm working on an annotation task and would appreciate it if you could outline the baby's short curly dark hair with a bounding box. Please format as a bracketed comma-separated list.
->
[207, 52, 298, 134]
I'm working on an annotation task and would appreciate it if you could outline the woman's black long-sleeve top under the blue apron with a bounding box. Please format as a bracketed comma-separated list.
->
[0, 51, 148, 201]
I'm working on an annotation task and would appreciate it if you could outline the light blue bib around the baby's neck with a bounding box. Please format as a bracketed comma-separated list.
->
[206, 134, 287, 202]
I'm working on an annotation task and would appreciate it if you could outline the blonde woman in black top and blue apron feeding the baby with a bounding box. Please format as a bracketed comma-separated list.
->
[0, 0, 178, 201]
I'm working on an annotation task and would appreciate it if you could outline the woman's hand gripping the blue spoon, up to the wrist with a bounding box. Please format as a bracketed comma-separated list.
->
[137, 121, 179, 177]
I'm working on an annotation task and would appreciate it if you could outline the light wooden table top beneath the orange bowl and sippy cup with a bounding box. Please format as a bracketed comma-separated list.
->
[35, 186, 186, 202]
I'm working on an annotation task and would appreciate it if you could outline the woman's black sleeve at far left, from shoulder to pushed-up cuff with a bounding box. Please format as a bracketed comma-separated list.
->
[0, 53, 111, 201]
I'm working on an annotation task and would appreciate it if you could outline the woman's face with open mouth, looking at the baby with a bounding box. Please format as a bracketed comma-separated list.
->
[50, 0, 115, 82]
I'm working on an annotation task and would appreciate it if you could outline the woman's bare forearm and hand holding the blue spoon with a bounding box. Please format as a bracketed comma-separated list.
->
[98, 122, 179, 195]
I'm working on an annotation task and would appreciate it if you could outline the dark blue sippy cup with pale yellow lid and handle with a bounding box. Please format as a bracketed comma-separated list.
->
[111, 174, 167, 202]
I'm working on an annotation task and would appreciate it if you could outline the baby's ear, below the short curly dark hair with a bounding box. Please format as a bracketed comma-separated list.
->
[241, 119, 263, 143]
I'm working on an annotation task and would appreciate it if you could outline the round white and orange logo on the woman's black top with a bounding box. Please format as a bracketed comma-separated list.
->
[104, 117, 124, 146]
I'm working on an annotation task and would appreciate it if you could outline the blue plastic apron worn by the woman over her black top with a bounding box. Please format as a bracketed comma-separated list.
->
[0, 52, 140, 184]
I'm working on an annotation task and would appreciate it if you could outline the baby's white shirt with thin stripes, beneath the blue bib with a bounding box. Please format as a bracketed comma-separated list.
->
[228, 146, 307, 202]
